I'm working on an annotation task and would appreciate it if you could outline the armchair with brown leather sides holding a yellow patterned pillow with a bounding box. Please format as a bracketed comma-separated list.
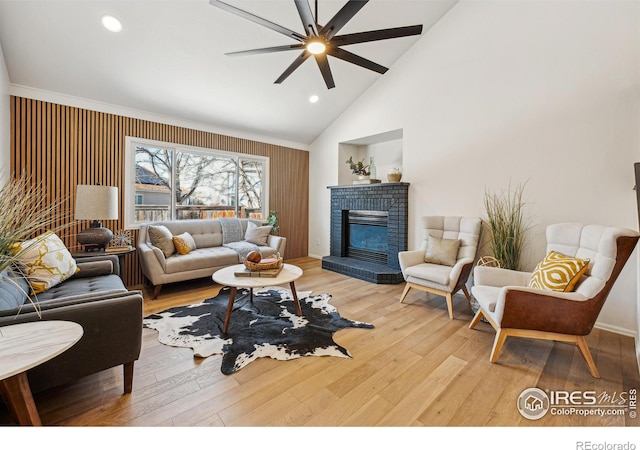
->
[469, 223, 639, 378]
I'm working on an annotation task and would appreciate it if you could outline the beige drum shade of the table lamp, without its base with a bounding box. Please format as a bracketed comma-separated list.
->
[75, 184, 118, 220]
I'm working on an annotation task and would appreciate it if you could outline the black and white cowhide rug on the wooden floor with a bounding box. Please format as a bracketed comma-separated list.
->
[143, 287, 373, 375]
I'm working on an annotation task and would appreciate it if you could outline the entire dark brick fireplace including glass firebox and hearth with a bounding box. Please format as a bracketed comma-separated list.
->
[322, 183, 409, 284]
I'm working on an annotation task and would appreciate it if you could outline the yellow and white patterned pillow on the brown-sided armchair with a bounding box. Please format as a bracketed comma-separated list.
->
[529, 250, 589, 292]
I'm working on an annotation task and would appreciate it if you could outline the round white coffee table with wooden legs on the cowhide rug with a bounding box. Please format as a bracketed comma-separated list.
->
[211, 264, 302, 333]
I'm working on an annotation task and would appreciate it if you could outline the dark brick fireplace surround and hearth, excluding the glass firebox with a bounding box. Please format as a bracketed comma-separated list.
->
[322, 183, 409, 284]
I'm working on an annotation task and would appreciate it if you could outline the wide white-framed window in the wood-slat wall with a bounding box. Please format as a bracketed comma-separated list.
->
[125, 138, 268, 227]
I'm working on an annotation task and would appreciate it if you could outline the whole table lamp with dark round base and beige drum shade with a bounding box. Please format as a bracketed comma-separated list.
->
[75, 184, 118, 251]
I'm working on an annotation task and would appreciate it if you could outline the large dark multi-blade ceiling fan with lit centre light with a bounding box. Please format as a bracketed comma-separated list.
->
[209, 0, 422, 89]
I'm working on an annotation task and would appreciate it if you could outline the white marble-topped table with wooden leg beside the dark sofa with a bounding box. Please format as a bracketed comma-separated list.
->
[0, 320, 84, 425]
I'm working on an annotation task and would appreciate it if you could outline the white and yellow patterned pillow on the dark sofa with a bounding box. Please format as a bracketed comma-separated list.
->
[14, 231, 79, 294]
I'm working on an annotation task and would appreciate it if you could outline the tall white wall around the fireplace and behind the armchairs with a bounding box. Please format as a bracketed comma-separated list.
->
[309, 0, 640, 334]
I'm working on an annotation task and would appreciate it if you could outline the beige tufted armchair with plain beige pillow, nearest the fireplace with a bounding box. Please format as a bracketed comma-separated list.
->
[398, 216, 482, 319]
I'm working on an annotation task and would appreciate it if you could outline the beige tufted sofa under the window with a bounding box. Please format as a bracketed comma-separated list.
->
[137, 219, 287, 299]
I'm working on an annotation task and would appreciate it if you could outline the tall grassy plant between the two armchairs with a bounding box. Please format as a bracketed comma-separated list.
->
[484, 183, 528, 270]
